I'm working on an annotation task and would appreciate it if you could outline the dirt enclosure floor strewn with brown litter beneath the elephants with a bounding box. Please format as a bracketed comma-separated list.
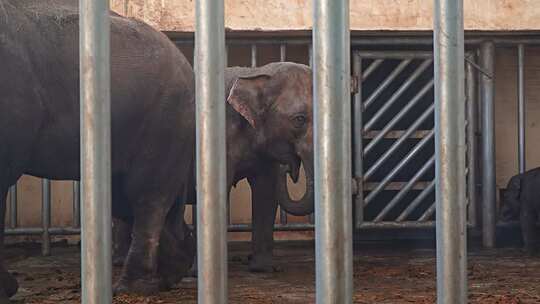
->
[4, 243, 540, 304]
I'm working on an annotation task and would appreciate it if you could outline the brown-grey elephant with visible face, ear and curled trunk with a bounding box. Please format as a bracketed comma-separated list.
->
[115, 62, 313, 274]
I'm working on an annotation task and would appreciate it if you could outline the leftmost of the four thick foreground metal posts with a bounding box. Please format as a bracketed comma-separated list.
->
[79, 0, 112, 304]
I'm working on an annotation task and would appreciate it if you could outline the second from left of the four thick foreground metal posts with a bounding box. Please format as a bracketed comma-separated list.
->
[195, 0, 228, 304]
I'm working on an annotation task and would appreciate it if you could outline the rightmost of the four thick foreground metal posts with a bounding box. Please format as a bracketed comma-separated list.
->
[432, 0, 467, 304]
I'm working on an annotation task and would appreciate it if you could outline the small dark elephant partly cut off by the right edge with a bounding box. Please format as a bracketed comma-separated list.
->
[501, 168, 540, 255]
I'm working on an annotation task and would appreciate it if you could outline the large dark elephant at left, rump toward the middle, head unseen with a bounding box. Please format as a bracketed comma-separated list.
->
[0, 0, 195, 304]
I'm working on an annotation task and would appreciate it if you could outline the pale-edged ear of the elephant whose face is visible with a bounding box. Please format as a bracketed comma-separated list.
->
[227, 74, 270, 128]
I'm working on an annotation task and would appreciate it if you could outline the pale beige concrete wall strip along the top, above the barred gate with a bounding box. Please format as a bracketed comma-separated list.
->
[111, 0, 540, 32]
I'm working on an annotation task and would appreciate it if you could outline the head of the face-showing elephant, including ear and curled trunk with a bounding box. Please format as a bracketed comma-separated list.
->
[227, 62, 314, 215]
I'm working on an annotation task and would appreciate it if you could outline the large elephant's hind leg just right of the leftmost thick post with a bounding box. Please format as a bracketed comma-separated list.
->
[115, 198, 173, 295]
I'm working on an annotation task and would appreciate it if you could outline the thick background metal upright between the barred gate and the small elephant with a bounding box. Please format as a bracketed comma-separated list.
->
[480, 42, 496, 248]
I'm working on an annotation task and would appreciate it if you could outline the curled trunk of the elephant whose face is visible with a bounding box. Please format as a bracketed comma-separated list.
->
[277, 154, 315, 216]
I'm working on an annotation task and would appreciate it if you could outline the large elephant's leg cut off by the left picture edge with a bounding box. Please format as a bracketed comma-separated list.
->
[0, 185, 19, 304]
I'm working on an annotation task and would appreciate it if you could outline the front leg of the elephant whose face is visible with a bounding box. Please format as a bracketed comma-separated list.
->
[249, 168, 278, 272]
